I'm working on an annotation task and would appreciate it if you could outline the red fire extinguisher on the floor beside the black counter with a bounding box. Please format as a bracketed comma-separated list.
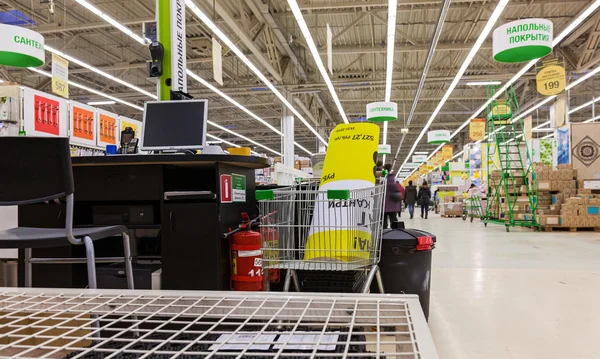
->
[231, 213, 264, 291]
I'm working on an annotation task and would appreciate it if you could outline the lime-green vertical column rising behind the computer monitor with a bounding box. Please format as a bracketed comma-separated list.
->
[156, 0, 171, 101]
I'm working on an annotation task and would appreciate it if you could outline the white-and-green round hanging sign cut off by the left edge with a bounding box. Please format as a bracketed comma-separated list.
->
[0, 24, 46, 67]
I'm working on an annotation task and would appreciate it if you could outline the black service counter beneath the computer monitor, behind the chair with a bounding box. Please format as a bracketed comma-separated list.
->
[18, 154, 268, 290]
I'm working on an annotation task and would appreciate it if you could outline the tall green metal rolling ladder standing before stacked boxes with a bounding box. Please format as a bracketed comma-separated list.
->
[484, 86, 539, 232]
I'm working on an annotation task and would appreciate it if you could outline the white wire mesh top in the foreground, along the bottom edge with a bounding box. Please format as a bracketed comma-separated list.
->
[0, 288, 437, 359]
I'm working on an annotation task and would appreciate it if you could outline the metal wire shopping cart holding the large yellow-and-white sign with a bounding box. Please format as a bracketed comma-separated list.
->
[256, 181, 385, 293]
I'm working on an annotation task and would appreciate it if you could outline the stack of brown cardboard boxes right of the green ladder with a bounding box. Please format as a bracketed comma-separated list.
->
[535, 164, 600, 228]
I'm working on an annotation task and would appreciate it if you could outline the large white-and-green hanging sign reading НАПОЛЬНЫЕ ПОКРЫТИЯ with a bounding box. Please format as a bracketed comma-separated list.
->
[492, 19, 553, 63]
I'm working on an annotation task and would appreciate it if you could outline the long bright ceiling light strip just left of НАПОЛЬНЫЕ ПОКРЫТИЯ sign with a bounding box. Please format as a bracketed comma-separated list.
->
[401, 0, 508, 172]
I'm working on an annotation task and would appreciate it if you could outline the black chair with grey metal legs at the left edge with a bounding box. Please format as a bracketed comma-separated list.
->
[0, 137, 133, 289]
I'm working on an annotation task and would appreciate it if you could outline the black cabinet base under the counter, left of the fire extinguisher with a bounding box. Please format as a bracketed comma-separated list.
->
[161, 202, 223, 290]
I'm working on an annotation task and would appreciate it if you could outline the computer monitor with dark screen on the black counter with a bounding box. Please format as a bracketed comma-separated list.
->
[140, 100, 208, 151]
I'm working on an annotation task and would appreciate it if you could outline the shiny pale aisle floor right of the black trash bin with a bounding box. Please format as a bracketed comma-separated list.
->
[403, 213, 600, 359]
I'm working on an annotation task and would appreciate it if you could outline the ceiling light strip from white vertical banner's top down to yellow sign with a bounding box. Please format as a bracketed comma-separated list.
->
[185, 0, 327, 146]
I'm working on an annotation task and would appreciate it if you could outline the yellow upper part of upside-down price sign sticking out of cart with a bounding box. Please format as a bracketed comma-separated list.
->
[321, 123, 379, 186]
